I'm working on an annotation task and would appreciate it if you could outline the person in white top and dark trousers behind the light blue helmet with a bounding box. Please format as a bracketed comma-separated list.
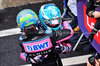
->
[67, 0, 82, 42]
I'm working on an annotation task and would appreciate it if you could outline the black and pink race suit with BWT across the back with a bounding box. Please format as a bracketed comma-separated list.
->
[19, 21, 73, 66]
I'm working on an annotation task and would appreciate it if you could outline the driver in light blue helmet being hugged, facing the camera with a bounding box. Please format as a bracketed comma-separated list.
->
[39, 3, 74, 50]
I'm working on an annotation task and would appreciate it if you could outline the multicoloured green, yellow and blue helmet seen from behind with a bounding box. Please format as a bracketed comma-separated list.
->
[16, 9, 39, 31]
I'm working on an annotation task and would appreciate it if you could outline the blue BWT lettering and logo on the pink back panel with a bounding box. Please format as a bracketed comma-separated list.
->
[26, 42, 49, 51]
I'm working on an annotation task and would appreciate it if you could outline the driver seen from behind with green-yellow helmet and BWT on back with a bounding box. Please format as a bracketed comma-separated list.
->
[17, 9, 72, 66]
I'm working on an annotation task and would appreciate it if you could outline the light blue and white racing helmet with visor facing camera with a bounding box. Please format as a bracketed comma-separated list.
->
[39, 3, 62, 30]
